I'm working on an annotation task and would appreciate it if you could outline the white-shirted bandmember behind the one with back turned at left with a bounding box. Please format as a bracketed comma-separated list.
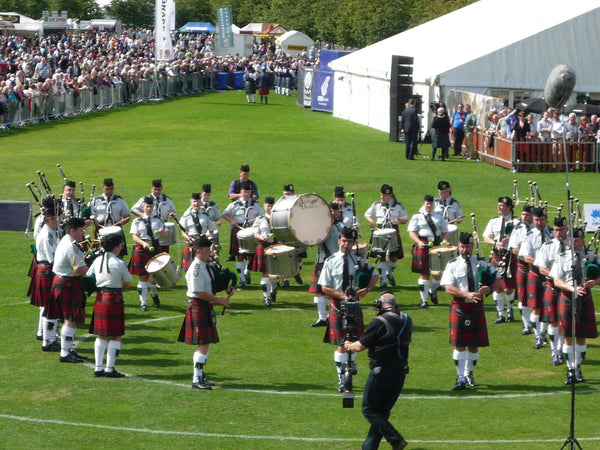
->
[90, 178, 131, 258]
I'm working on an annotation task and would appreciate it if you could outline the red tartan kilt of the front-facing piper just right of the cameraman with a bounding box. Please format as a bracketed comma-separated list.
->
[449, 298, 490, 347]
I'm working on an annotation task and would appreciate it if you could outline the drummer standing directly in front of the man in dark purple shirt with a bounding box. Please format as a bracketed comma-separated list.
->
[223, 181, 265, 288]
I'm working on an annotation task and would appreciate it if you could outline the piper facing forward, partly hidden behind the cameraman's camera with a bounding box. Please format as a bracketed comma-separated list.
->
[318, 227, 379, 393]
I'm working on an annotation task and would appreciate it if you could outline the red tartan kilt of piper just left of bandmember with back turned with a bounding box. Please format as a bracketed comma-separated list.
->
[44, 275, 86, 323]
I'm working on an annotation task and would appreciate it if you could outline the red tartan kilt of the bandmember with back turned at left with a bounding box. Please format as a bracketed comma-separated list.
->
[90, 288, 125, 337]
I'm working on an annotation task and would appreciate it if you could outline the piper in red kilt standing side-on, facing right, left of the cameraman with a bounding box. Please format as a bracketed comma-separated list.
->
[178, 237, 233, 390]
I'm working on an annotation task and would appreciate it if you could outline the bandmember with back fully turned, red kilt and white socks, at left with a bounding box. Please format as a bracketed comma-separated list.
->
[88, 233, 133, 378]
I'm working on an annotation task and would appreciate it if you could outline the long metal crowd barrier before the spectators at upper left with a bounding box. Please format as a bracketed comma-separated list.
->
[0, 73, 217, 129]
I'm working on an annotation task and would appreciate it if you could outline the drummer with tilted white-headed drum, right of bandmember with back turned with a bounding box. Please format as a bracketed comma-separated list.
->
[129, 195, 168, 311]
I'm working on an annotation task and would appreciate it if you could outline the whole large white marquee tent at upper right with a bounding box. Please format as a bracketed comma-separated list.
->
[329, 0, 600, 132]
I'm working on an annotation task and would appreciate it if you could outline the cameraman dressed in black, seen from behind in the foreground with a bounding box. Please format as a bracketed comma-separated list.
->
[344, 291, 413, 450]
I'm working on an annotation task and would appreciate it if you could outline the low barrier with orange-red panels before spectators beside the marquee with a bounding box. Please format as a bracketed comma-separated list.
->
[473, 131, 600, 172]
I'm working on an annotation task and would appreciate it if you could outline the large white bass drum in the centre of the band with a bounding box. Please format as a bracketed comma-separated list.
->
[271, 194, 333, 247]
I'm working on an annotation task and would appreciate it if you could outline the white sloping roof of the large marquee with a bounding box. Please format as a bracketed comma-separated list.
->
[330, 0, 600, 88]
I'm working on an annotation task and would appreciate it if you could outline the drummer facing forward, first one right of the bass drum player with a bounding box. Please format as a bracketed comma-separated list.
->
[365, 184, 408, 289]
